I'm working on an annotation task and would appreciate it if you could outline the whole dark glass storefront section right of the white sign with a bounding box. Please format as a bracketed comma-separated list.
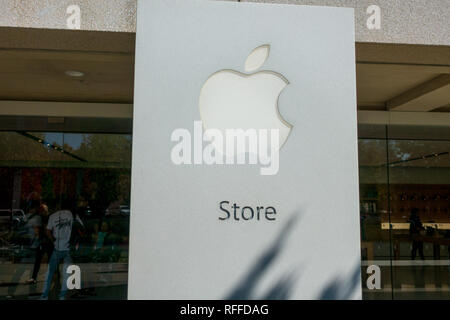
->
[359, 125, 450, 299]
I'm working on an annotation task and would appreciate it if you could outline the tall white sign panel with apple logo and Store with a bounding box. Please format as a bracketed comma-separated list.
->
[128, 0, 361, 299]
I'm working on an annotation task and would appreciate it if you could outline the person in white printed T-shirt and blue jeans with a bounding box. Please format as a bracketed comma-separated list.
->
[41, 200, 84, 300]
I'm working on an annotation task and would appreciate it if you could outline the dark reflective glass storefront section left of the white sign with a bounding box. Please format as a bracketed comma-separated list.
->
[0, 125, 132, 299]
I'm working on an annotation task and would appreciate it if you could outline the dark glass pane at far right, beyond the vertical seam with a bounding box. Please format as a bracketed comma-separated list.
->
[389, 126, 450, 299]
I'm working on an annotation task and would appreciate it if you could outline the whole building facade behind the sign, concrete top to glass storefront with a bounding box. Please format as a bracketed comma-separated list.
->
[0, 0, 450, 299]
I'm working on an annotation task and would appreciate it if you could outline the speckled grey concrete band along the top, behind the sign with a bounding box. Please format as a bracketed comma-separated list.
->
[0, 0, 450, 46]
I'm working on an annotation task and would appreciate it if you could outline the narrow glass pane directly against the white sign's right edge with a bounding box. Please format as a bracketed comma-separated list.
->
[359, 125, 392, 299]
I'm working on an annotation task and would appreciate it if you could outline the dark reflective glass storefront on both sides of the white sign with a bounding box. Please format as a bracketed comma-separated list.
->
[0, 119, 450, 299]
